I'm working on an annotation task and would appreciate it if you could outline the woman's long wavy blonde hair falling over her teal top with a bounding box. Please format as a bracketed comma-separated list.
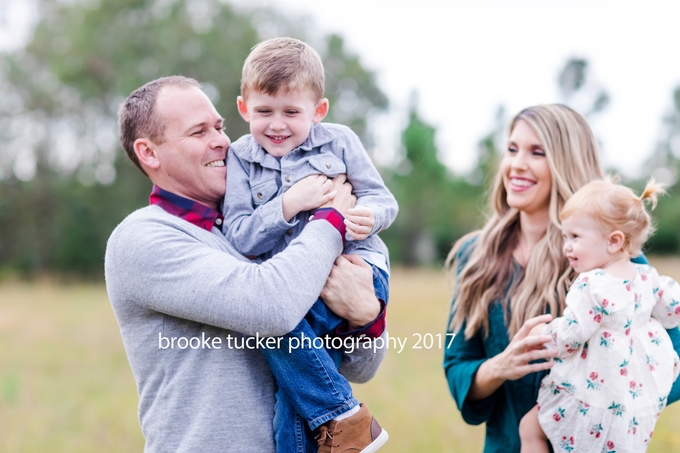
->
[447, 104, 603, 338]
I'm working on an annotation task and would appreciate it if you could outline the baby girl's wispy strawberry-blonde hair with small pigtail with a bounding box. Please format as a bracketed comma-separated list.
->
[560, 178, 666, 256]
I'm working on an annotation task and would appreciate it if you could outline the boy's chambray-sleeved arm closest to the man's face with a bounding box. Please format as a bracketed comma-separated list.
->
[223, 150, 297, 256]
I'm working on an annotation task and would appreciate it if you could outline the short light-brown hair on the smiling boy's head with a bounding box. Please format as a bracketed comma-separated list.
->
[241, 38, 326, 101]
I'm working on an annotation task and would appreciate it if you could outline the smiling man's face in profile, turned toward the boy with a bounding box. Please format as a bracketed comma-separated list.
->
[153, 86, 229, 209]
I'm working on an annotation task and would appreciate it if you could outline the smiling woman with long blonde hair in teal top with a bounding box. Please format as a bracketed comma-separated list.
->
[444, 105, 680, 453]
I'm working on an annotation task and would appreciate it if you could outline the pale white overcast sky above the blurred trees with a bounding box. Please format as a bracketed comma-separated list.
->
[0, 0, 680, 175]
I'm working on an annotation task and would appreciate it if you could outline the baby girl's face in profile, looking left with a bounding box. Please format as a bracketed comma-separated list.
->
[562, 214, 611, 273]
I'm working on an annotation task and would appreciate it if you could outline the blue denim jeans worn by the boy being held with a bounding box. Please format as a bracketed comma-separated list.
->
[261, 266, 389, 453]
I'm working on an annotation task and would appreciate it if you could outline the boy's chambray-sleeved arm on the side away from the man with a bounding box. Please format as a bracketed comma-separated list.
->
[333, 126, 399, 234]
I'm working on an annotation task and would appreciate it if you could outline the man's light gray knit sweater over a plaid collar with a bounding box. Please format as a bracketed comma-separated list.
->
[105, 206, 385, 453]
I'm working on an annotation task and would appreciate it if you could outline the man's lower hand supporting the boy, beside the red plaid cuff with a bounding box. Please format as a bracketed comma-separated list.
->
[321, 255, 380, 330]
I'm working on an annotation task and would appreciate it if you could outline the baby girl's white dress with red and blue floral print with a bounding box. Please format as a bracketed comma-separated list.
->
[538, 265, 680, 453]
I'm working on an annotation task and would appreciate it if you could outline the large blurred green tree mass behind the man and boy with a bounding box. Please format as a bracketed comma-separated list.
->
[0, 0, 387, 276]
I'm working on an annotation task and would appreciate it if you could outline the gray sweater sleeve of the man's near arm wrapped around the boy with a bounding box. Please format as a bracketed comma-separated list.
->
[105, 208, 342, 335]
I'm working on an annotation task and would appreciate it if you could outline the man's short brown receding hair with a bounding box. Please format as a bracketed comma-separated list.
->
[118, 76, 201, 176]
